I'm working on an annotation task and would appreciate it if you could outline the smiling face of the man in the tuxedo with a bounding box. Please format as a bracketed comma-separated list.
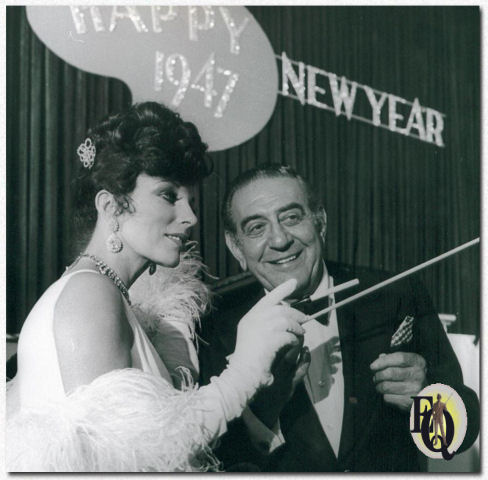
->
[226, 177, 326, 299]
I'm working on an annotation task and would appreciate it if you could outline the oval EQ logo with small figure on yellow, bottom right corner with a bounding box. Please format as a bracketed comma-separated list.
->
[410, 383, 468, 460]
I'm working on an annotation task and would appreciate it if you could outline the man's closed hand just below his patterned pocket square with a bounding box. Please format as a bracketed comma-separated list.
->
[370, 352, 426, 411]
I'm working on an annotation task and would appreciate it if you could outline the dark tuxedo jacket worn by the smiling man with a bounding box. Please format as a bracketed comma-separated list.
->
[199, 262, 479, 472]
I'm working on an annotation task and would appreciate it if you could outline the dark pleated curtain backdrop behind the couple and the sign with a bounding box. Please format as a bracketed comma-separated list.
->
[7, 6, 480, 334]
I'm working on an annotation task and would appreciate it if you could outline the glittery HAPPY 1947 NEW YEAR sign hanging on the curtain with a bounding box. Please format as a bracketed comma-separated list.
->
[27, 5, 445, 150]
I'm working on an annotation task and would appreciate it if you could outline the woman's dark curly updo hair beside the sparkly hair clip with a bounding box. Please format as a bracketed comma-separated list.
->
[73, 102, 212, 244]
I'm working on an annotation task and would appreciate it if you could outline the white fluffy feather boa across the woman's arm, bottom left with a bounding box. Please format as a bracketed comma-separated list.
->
[6, 368, 218, 472]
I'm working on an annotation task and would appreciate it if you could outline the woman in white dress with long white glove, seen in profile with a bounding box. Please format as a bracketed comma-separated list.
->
[6, 102, 304, 472]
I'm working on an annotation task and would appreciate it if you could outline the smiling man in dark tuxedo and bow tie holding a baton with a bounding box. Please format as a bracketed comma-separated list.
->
[200, 165, 479, 472]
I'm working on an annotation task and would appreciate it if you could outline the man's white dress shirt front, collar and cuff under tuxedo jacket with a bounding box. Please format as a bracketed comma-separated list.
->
[243, 265, 344, 456]
